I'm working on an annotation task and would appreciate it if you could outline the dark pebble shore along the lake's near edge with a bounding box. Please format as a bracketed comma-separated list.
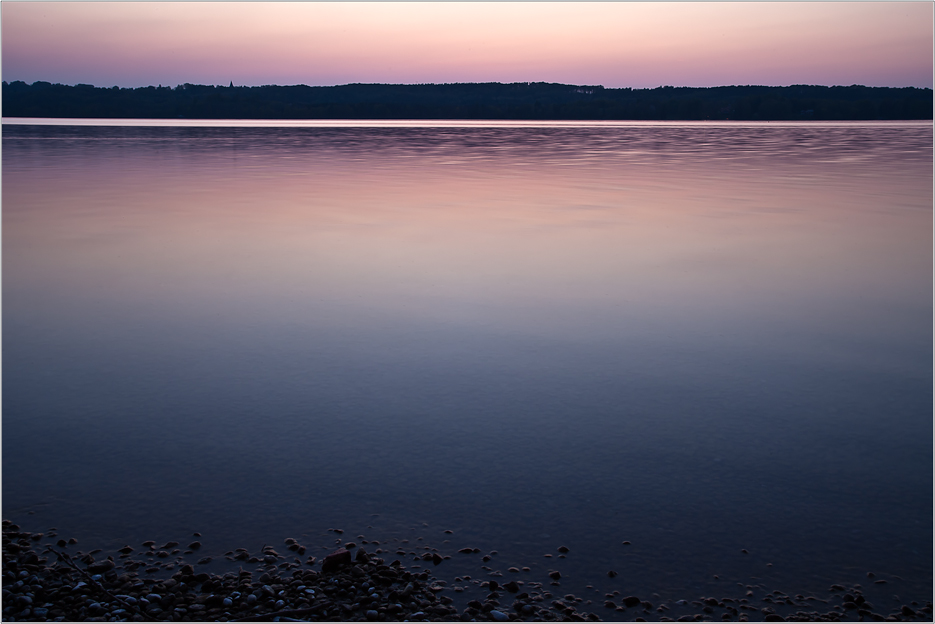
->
[2, 520, 932, 622]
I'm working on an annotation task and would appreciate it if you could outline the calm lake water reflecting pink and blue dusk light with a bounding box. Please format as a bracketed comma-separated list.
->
[3, 124, 932, 593]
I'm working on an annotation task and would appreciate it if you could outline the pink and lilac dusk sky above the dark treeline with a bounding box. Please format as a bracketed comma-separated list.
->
[0, 1, 935, 88]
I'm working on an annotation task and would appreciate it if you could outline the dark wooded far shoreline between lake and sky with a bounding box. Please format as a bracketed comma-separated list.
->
[3, 81, 932, 121]
